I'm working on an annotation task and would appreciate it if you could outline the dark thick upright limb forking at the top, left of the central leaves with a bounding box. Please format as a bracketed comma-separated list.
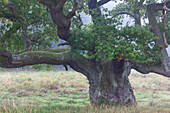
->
[39, 0, 72, 41]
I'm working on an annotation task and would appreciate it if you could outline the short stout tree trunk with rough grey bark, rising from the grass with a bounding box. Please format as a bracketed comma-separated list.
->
[89, 60, 137, 105]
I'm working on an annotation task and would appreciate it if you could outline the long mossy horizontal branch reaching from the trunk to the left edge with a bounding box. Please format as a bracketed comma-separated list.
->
[0, 49, 93, 76]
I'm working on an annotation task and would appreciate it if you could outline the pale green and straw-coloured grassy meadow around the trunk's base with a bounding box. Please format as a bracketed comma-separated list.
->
[0, 71, 170, 113]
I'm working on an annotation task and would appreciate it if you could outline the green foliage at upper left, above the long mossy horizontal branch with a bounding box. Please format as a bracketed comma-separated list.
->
[0, 0, 58, 52]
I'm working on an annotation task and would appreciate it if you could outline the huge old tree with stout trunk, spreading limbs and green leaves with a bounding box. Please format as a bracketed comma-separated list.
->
[0, 0, 170, 105]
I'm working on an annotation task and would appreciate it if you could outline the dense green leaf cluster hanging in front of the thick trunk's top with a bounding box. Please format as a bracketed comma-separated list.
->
[71, 17, 161, 64]
